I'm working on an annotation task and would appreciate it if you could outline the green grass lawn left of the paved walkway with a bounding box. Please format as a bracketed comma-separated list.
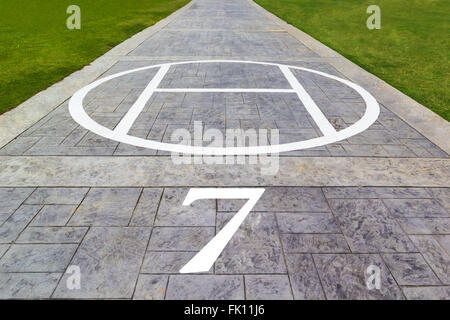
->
[0, 0, 189, 114]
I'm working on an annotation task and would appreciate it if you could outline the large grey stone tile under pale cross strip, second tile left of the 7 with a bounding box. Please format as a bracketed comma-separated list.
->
[68, 188, 141, 226]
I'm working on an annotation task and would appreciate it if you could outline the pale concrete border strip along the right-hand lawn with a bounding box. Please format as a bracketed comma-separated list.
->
[248, 0, 450, 154]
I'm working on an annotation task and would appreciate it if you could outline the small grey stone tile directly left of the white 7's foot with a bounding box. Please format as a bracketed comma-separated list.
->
[141, 251, 212, 274]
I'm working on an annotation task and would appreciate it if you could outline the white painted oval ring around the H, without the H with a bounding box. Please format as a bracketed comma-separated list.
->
[69, 60, 380, 155]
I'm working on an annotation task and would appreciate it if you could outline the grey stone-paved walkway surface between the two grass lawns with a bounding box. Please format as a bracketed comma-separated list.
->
[0, 0, 450, 299]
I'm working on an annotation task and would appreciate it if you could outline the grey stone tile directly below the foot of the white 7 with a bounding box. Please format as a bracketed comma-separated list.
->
[166, 275, 244, 300]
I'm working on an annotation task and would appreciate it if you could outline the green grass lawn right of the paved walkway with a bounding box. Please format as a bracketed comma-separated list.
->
[255, 0, 450, 120]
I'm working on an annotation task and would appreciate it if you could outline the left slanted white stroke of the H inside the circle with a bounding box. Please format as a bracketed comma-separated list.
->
[114, 64, 170, 134]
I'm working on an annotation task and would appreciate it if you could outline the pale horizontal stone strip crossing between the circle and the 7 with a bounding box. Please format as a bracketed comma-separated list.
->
[0, 156, 450, 187]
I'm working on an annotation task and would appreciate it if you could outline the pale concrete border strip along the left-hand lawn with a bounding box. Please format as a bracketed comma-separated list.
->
[0, 0, 195, 148]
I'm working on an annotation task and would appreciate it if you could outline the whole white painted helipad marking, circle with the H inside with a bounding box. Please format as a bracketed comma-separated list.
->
[69, 60, 380, 155]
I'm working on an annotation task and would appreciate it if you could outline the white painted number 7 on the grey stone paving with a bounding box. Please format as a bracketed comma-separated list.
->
[180, 188, 265, 273]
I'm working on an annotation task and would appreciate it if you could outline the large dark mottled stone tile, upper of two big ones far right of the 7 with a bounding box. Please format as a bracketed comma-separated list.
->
[329, 199, 416, 253]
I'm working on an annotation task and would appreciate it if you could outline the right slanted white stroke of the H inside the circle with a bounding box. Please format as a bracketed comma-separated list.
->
[280, 65, 336, 136]
